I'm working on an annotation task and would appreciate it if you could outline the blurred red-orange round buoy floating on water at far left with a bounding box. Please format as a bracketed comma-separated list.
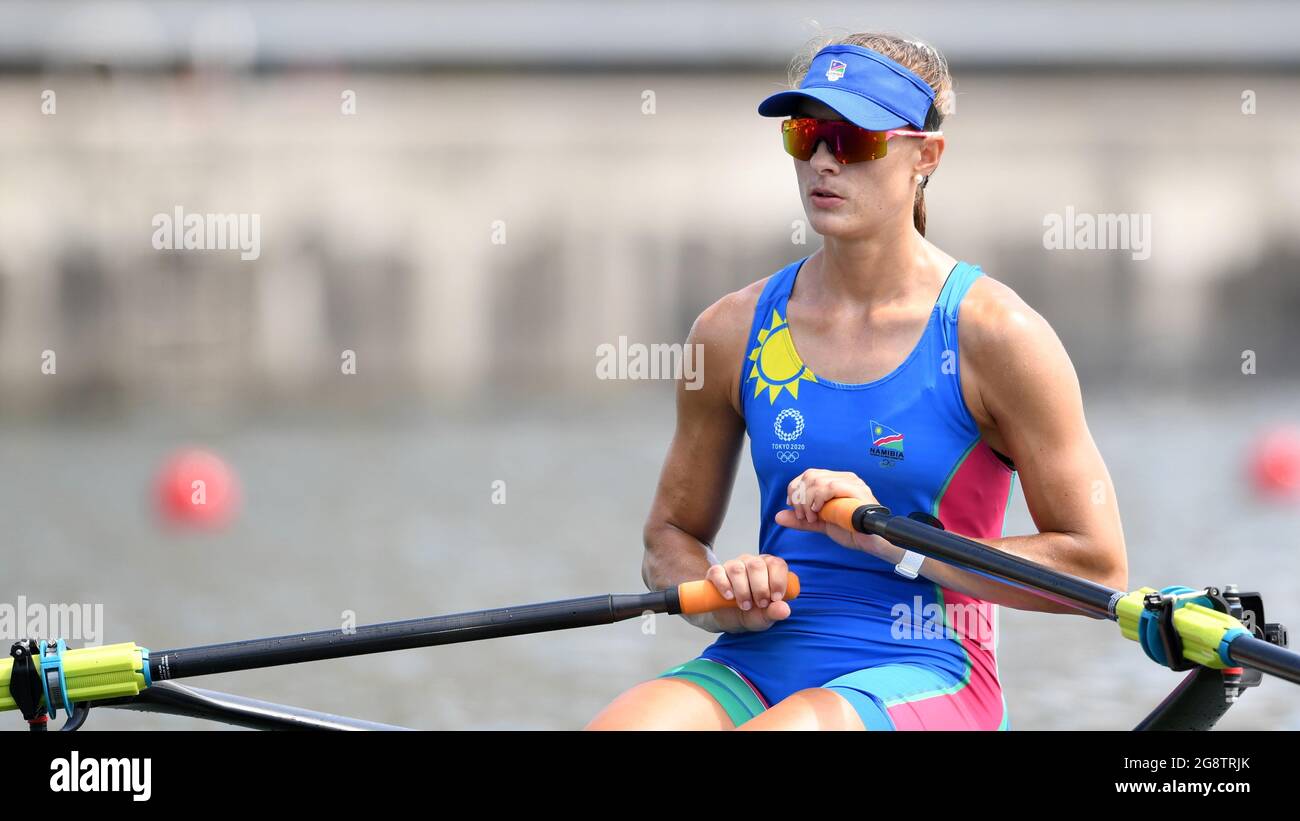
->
[155, 448, 239, 527]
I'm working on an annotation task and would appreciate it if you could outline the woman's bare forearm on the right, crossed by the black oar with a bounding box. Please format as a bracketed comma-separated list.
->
[922, 533, 1128, 613]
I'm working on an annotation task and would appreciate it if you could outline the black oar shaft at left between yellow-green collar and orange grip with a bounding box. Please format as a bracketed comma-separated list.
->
[150, 588, 679, 681]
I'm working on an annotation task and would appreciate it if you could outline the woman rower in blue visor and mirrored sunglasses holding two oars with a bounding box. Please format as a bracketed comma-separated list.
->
[589, 34, 1127, 730]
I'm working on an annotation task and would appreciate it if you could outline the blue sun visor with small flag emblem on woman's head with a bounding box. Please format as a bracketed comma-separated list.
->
[758, 45, 935, 131]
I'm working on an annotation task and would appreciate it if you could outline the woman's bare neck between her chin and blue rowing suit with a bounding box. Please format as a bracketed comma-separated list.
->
[813, 224, 941, 304]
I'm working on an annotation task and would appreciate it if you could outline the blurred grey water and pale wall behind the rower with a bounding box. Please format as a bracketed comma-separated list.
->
[0, 0, 1300, 729]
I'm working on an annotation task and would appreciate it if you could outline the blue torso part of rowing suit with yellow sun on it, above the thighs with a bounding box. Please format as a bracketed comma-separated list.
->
[702, 257, 1014, 704]
